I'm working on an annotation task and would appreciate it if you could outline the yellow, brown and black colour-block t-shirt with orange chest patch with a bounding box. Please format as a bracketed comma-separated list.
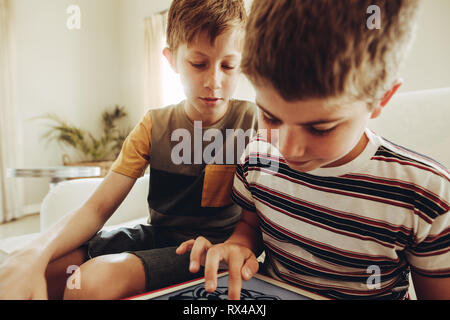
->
[111, 100, 257, 241]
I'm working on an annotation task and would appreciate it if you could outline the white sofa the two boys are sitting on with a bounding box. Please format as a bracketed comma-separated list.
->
[0, 88, 450, 298]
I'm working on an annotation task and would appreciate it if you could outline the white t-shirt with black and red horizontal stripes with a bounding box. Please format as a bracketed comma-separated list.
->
[232, 130, 450, 299]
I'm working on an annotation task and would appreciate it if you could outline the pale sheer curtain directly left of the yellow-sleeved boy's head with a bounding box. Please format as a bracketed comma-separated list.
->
[144, 12, 167, 109]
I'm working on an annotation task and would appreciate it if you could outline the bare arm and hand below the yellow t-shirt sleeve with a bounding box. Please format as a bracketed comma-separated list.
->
[0, 172, 136, 299]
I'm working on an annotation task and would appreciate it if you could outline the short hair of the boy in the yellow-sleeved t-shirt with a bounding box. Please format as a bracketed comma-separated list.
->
[167, 0, 247, 52]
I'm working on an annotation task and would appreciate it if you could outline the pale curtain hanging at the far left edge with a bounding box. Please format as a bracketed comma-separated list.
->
[0, 0, 24, 223]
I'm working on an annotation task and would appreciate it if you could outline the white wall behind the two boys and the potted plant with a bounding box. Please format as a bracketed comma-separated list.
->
[8, 0, 450, 212]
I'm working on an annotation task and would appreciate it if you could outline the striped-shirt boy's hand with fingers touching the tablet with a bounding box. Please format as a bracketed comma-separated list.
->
[177, 237, 259, 300]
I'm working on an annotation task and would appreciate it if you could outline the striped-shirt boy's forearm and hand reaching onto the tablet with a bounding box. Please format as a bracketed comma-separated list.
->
[177, 210, 262, 300]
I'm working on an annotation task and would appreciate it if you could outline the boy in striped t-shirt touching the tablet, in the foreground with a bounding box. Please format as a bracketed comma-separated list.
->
[178, 0, 450, 299]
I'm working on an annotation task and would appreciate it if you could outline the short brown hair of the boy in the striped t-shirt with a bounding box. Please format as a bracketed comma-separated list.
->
[242, 0, 419, 104]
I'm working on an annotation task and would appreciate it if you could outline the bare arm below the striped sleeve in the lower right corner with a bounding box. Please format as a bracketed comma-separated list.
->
[411, 271, 450, 300]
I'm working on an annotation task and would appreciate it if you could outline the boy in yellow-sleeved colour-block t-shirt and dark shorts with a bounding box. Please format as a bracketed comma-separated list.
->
[0, 0, 256, 299]
